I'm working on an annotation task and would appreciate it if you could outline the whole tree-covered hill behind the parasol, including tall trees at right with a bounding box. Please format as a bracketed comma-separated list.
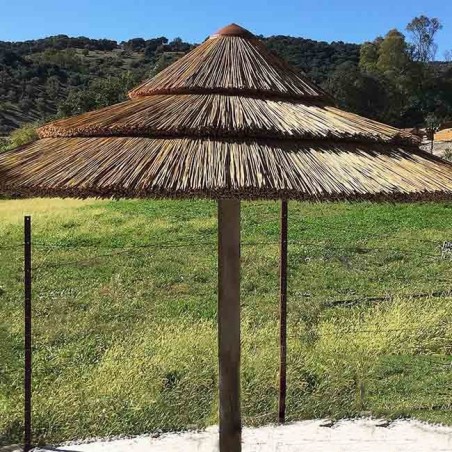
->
[0, 16, 452, 139]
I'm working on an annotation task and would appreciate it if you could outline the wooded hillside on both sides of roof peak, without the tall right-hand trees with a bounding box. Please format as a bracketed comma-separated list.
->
[0, 35, 359, 135]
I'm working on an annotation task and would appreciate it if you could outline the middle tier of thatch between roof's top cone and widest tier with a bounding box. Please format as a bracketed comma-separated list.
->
[38, 94, 415, 143]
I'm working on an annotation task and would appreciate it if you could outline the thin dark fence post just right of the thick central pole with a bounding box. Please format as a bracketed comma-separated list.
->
[278, 200, 287, 424]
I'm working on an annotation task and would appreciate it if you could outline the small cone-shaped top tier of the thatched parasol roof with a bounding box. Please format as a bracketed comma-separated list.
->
[129, 24, 326, 100]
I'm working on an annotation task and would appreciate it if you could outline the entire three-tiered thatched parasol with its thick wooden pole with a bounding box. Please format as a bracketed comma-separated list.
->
[0, 24, 452, 452]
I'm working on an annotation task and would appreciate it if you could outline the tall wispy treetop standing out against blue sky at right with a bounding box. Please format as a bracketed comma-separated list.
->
[406, 16, 443, 63]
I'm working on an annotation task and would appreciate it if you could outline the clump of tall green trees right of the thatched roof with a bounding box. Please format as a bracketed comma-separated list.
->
[327, 16, 452, 127]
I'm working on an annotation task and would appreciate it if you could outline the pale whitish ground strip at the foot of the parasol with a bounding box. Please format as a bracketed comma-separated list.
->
[28, 419, 452, 452]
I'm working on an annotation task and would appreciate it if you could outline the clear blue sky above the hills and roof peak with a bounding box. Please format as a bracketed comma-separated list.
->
[0, 0, 452, 57]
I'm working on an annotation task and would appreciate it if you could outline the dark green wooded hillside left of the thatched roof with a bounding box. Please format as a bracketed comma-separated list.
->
[0, 35, 193, 134]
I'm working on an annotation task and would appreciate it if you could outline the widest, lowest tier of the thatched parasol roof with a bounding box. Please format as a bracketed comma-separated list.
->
[0, 137, 452, 201]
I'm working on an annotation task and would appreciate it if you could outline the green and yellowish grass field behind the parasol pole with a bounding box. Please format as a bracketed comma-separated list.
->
[0, 200, 452, 443]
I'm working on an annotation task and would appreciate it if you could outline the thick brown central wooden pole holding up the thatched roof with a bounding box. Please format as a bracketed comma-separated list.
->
[218, 199, 242, 452]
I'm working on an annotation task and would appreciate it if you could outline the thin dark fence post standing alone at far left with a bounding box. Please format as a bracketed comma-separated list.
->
[24, 216, 31, 452]
